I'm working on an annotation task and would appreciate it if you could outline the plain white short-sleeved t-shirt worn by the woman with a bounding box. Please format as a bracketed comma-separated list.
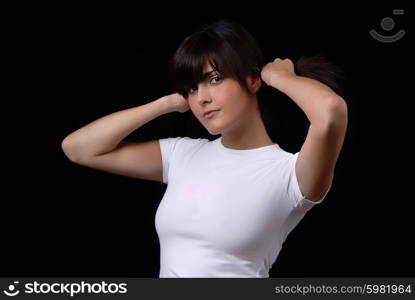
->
[155, 137, 331, 278]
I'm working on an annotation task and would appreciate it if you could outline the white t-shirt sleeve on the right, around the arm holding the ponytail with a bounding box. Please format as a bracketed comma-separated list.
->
[287, 152, 331, 210]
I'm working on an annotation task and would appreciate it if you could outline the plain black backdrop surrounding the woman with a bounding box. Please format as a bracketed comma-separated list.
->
[0, 1, 415, 277]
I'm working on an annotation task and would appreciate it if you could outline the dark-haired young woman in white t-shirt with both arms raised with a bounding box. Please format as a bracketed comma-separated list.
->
[62, 20, 347, 277]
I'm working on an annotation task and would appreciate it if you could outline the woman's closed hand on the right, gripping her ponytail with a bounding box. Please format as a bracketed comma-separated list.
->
[261, 58, 295, 86]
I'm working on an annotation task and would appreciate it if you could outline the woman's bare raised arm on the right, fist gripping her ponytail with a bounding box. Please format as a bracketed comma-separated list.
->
[261, 58, 348, 201]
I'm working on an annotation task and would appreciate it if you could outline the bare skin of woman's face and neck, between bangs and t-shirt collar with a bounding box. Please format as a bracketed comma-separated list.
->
[187, 63, 273, 150]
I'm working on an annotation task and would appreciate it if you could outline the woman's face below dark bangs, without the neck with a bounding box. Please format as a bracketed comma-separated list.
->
[187, 63, 252, 135]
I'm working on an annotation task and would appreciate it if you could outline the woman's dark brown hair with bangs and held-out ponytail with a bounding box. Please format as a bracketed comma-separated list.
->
[170, 19, 341, 98]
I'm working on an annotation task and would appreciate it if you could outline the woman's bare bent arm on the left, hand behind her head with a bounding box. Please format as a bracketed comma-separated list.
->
[62, 94, 189, 182]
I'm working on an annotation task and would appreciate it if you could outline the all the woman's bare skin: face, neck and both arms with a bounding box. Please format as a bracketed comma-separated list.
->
[62, 54, 348, 201]
